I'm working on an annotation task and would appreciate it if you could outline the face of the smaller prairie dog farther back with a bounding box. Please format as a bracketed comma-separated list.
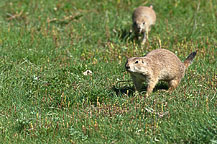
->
[133, 18, 149, 33]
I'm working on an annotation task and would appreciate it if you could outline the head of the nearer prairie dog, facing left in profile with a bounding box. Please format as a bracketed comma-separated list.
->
[125, 57, 149, 75]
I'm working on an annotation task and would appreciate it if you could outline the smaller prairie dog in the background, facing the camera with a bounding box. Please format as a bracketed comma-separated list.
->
[132, 5, 156, 44]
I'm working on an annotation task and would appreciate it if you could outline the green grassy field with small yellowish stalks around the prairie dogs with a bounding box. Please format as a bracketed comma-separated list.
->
[0, 0, 217, 144]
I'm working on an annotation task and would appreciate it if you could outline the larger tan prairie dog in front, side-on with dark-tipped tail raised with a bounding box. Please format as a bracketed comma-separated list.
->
[125, 49, 197, 96]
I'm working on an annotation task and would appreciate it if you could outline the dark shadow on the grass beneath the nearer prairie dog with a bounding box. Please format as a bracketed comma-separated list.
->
[112, 82, 169, 96]
